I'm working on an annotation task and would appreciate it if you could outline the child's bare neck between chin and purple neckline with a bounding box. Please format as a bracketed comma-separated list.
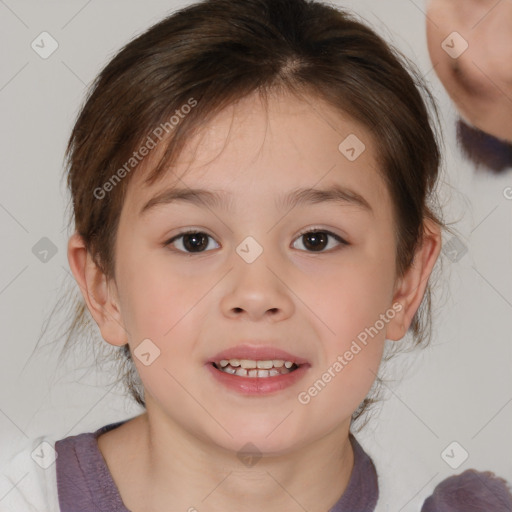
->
[120, 413, 354, 512]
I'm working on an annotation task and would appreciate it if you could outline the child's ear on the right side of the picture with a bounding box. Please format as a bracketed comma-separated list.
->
[386, 219, 441, 341]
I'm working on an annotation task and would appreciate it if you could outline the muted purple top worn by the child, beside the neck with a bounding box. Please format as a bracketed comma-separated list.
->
[55, 420, 379, 512]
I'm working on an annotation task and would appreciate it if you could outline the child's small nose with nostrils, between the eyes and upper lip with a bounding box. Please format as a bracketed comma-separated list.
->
[221, 236, 293, 319]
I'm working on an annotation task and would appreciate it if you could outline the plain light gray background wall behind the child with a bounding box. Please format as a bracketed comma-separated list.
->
[0, 0, 512, 512]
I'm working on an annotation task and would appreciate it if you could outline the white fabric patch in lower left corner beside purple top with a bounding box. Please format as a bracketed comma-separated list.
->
[0, 435, 59, 512]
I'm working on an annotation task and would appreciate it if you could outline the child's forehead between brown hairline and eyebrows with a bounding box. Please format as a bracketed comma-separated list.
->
[125, 94, 389, 217]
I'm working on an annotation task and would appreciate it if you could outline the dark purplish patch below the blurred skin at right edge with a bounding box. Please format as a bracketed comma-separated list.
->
[457, 119, 512, 173]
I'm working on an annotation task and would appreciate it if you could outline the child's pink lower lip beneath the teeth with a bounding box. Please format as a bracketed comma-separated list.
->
[206, 363, 310, 395]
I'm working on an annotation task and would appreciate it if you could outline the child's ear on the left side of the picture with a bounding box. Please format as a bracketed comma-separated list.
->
[68, 232, 128, 346]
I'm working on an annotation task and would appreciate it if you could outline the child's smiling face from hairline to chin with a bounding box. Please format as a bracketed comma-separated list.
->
[114, 91, 404, 452]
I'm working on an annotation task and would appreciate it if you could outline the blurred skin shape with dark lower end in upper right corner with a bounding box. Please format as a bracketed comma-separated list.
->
[426, 0, 512, 173]
